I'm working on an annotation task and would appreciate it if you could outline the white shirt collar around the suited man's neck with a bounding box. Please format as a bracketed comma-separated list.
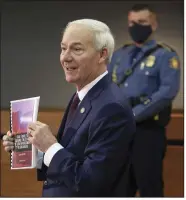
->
[77, 71, 108, 101]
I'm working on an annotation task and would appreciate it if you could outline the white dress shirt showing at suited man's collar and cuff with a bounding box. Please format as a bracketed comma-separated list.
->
[37, 71, 108, 168]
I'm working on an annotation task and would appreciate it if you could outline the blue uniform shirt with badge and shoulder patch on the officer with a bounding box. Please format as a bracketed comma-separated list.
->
[108, 40, 180, 121]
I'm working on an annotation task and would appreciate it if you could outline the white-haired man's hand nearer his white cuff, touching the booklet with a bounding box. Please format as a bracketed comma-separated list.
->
[27, 121, 57, 153]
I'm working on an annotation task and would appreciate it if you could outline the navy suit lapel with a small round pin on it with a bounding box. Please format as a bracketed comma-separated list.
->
[61, 75, 109, 147]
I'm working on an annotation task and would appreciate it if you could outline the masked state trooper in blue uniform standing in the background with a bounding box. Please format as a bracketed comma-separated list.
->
[108, 4, 180, 197]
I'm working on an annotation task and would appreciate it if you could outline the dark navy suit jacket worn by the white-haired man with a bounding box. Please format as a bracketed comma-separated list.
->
[38, 75, 135, 197]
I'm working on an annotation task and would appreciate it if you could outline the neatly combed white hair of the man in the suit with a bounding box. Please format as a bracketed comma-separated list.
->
[64, 19, 115, 62]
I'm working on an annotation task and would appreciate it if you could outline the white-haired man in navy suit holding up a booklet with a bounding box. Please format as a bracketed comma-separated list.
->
[4, 19, 135, 197]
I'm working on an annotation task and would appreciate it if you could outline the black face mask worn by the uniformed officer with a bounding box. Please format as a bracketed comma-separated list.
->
[129, 23, 152, 44]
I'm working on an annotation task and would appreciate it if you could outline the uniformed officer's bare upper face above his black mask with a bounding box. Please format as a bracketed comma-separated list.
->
[128, 10, 157, 31]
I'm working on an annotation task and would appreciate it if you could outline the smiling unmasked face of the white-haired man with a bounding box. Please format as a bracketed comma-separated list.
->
[60, 24, 100, 89]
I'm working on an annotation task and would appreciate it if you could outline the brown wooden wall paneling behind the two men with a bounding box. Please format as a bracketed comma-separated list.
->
[0, 110, 184, 197]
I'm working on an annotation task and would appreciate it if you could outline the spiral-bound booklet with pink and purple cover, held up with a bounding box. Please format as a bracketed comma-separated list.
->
[10, 97, 40, 169]
